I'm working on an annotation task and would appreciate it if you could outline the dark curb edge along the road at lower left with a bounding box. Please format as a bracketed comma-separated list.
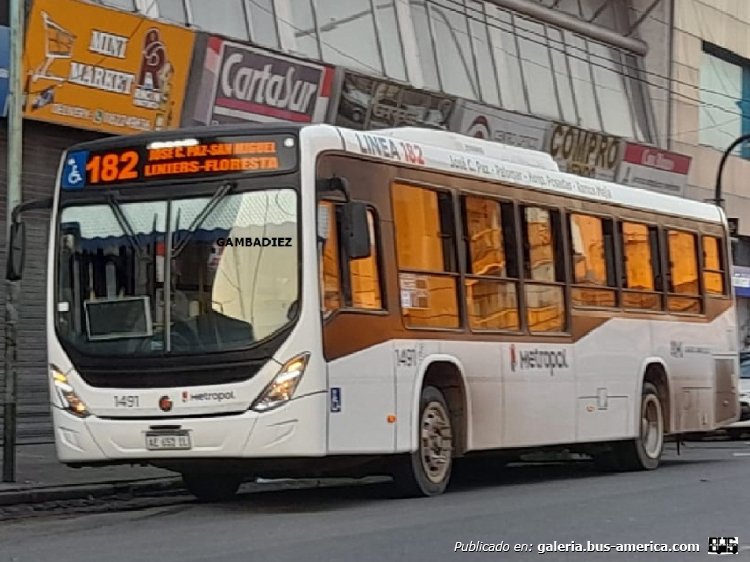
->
[0, 478, 182, 507]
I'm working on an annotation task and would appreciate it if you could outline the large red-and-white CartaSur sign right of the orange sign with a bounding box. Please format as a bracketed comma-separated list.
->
[190, 37, 334, 125]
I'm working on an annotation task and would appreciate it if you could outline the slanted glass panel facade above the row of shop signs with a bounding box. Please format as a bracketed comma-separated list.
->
[138, 0, 656, 144]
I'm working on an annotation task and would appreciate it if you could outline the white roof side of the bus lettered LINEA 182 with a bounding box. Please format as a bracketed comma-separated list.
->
[322, 125, 724, 222]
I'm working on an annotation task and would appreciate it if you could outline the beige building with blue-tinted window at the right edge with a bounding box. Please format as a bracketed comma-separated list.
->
[667, 0, 750, 349]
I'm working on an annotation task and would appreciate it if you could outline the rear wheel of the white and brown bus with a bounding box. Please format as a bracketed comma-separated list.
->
[594, 382, 664, 471]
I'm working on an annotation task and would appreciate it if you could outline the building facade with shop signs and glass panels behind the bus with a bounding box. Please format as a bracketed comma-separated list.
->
[0, 0, 736, 442]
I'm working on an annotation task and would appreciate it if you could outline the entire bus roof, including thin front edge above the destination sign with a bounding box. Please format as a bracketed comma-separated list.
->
[63, 123, 724, 223]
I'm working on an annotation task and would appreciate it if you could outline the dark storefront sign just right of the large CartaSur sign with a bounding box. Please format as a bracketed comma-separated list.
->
[331, 72, 456, 130]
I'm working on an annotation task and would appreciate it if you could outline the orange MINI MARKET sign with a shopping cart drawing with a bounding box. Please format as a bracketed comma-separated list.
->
[24, 0, 194, 134]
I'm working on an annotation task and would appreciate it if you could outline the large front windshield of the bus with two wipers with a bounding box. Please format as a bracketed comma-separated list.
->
[55, 188, 300, 355]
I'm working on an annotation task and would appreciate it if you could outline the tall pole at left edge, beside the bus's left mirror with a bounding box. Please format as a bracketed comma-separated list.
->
[3, 0, 26, 482]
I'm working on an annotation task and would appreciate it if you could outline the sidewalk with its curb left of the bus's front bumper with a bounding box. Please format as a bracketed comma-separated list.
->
[0, 444, 180, 506]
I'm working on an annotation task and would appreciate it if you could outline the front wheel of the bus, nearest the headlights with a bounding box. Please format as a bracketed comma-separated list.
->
[392, 386, 454, 497]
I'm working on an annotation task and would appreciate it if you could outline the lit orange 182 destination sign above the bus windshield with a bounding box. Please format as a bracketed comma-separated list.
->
[61, 135, 297, 191]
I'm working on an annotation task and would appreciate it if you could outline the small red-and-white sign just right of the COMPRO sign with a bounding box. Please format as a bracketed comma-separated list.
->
[617, 142, 691, 197]
